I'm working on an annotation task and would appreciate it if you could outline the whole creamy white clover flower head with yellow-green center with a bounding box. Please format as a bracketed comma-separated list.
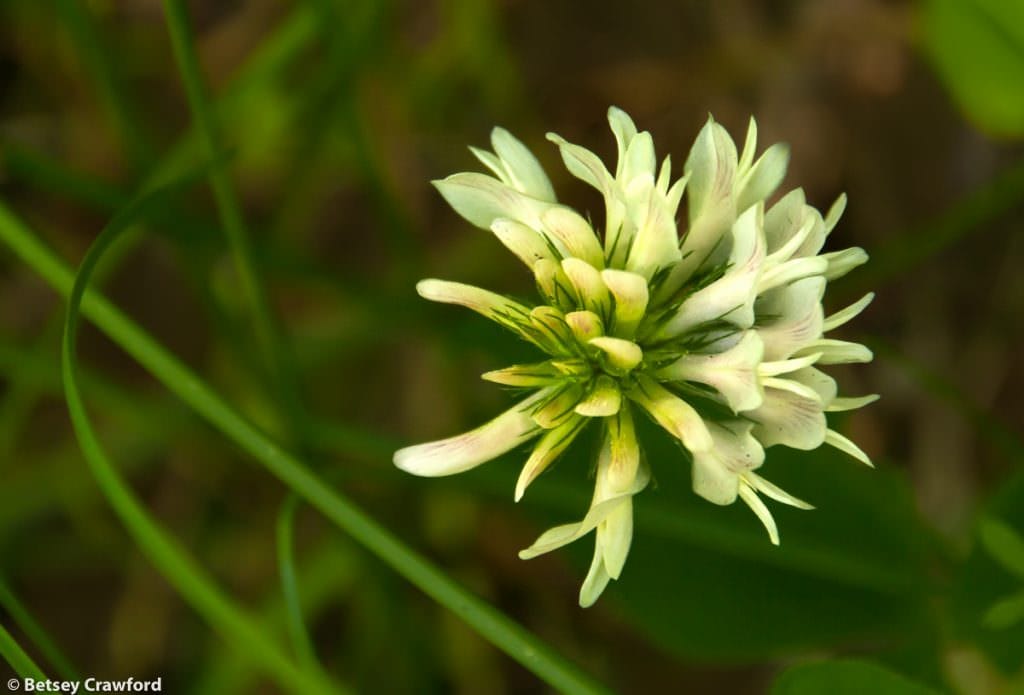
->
[394, 107, 877, 606]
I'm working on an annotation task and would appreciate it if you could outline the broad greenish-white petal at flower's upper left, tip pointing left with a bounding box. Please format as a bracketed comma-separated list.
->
[433, 172, 552, 229]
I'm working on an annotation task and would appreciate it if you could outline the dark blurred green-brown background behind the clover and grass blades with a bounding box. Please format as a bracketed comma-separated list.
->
[0, 0, 1024, 693]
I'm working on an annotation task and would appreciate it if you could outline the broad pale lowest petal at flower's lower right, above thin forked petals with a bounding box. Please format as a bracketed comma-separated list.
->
[692, 423, 765, 505]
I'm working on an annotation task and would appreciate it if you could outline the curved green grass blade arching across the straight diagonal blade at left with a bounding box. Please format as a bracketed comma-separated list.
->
[61, 190, 337, 693]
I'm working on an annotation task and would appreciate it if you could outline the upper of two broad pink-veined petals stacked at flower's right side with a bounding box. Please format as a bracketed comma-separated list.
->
[755, 277, 825, 361]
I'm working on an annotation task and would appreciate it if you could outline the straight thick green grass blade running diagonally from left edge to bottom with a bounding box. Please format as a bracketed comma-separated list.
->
[0, 199, 603, 693]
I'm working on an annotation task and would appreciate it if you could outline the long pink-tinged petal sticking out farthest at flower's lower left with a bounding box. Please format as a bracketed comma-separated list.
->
[394, 389, 550, 477]
